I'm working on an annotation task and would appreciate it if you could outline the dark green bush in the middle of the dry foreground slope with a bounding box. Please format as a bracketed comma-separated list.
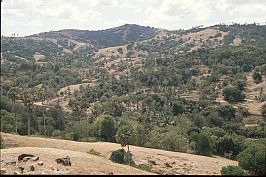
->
[109, 149, 135, 166]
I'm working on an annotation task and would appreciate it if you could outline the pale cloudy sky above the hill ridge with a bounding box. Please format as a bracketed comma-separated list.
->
[1, 0, 266, 36]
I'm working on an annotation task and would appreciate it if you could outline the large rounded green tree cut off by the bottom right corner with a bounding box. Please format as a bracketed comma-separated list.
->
[237, 143, 266, 175]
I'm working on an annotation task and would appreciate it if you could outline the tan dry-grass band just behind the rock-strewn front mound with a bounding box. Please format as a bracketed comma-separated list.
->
[1, 133, 237, 175]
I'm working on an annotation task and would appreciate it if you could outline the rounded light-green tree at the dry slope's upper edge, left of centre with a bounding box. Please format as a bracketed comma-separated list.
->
[94, 115, 116, 141]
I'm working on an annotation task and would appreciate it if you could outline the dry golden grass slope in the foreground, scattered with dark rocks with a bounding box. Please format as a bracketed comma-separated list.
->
[1, 133, 237, 175]
